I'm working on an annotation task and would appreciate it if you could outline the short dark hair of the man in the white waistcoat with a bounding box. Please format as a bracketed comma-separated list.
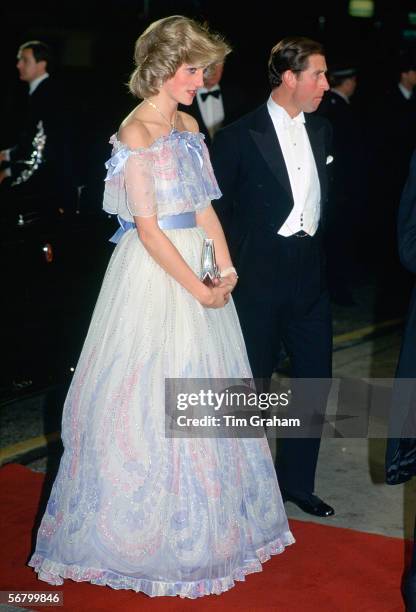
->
[268, 36, 325, 89]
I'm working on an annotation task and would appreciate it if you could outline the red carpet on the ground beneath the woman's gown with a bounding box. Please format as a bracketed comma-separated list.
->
[0, 464, 404, 612]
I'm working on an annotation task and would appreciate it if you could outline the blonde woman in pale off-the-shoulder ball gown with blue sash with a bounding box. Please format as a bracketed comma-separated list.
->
[30, 16, 294, 598]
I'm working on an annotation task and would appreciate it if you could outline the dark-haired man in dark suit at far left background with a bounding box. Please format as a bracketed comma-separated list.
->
[0, 40, 76, 216]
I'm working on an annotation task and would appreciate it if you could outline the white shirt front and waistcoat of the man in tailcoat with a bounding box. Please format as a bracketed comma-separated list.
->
[267, 96, 321, 236]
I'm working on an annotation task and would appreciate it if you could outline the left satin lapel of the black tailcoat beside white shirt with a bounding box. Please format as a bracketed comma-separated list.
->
[250, 105, 293, 200]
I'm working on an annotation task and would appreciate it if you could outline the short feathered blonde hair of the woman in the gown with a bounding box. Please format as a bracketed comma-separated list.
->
[129, 15, 231, 98]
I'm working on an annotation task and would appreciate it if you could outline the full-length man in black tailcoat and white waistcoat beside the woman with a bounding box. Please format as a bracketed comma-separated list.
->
[212, 37, 334, 516]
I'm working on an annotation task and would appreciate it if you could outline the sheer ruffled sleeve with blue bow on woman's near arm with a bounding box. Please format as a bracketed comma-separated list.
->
[103, 136, 157, 221]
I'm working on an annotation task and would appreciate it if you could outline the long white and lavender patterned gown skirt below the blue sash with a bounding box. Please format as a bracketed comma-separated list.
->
[29, 227, 294, 598]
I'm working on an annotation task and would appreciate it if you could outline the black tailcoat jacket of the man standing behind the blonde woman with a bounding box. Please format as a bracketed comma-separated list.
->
[212, 104, 331, 280]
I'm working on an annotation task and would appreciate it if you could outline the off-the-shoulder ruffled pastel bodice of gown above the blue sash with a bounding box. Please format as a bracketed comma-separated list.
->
[103, 131, 221, 221]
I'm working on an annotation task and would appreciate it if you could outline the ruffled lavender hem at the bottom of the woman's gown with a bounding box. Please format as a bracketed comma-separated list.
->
[29, 531, 295, 599]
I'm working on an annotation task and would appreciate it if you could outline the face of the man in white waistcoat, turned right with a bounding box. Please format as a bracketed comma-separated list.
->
[293, 54, 329, 113]
